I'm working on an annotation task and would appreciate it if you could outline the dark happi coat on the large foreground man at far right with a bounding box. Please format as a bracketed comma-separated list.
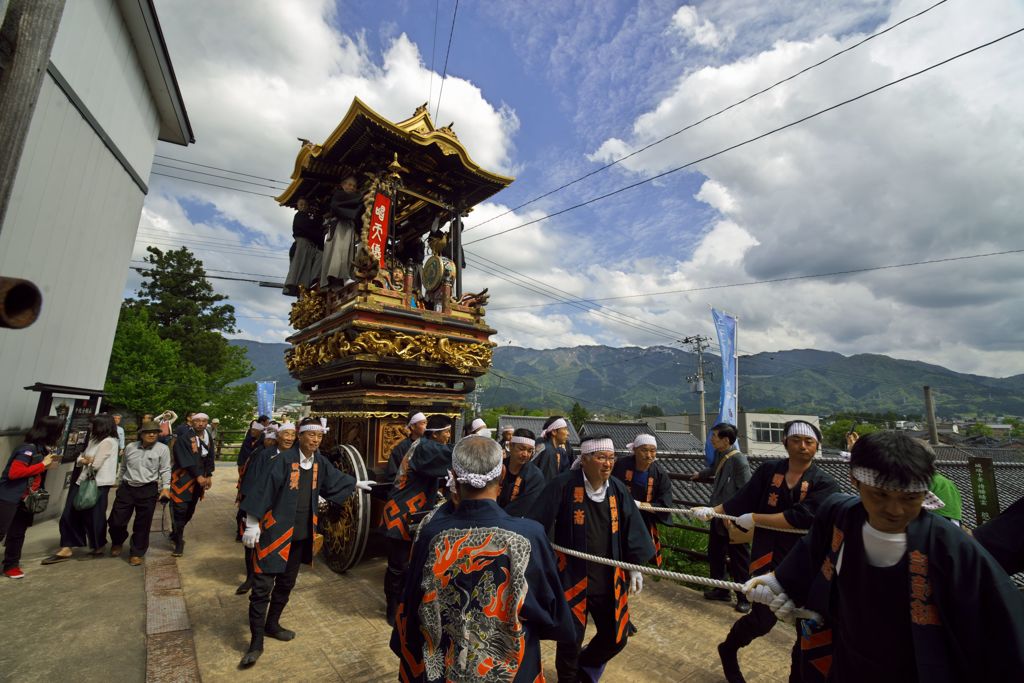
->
[775, 495, 1024, 683]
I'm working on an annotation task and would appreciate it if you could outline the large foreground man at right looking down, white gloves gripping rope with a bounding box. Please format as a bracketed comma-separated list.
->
[744, 431, 1024, 683]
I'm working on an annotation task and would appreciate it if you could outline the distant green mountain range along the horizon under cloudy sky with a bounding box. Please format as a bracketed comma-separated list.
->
[231, 340, 1024, 419]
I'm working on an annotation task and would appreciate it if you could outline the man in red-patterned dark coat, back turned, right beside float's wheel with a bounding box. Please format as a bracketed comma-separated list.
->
[383, 415, 452, 626]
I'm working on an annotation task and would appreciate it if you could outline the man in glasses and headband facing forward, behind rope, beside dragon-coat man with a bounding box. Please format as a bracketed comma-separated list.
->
[529, 436, 654, 681]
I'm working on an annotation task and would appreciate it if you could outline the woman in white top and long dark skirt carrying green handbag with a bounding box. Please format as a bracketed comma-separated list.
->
[42, 414, 118, 564]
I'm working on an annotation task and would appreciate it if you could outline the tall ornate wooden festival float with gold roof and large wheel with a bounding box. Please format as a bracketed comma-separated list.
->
[276, 98, 513, 571]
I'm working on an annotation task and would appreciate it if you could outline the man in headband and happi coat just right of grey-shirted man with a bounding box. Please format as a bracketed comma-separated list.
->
[171, 413, 215, 557]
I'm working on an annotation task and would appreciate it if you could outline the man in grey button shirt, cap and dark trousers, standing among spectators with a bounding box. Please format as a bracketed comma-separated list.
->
[106, 421, 171, 566]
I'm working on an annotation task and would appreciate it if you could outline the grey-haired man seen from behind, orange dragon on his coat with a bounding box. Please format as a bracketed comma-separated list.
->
[391, 435, 575, 683]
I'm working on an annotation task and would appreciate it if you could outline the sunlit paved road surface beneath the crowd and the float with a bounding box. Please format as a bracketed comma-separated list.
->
[0, 471, 794, 683]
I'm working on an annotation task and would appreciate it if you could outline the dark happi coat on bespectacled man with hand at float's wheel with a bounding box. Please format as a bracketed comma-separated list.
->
[241, 444, 355, 573]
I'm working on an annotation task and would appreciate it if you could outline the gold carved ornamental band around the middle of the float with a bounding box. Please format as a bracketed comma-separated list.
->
[285, 330, 493, 375]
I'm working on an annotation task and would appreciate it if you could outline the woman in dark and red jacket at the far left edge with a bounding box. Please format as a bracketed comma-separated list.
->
[0, 416, 63, 579]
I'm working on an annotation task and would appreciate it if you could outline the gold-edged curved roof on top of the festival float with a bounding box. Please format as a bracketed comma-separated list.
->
[276, 97, 514, 228]
